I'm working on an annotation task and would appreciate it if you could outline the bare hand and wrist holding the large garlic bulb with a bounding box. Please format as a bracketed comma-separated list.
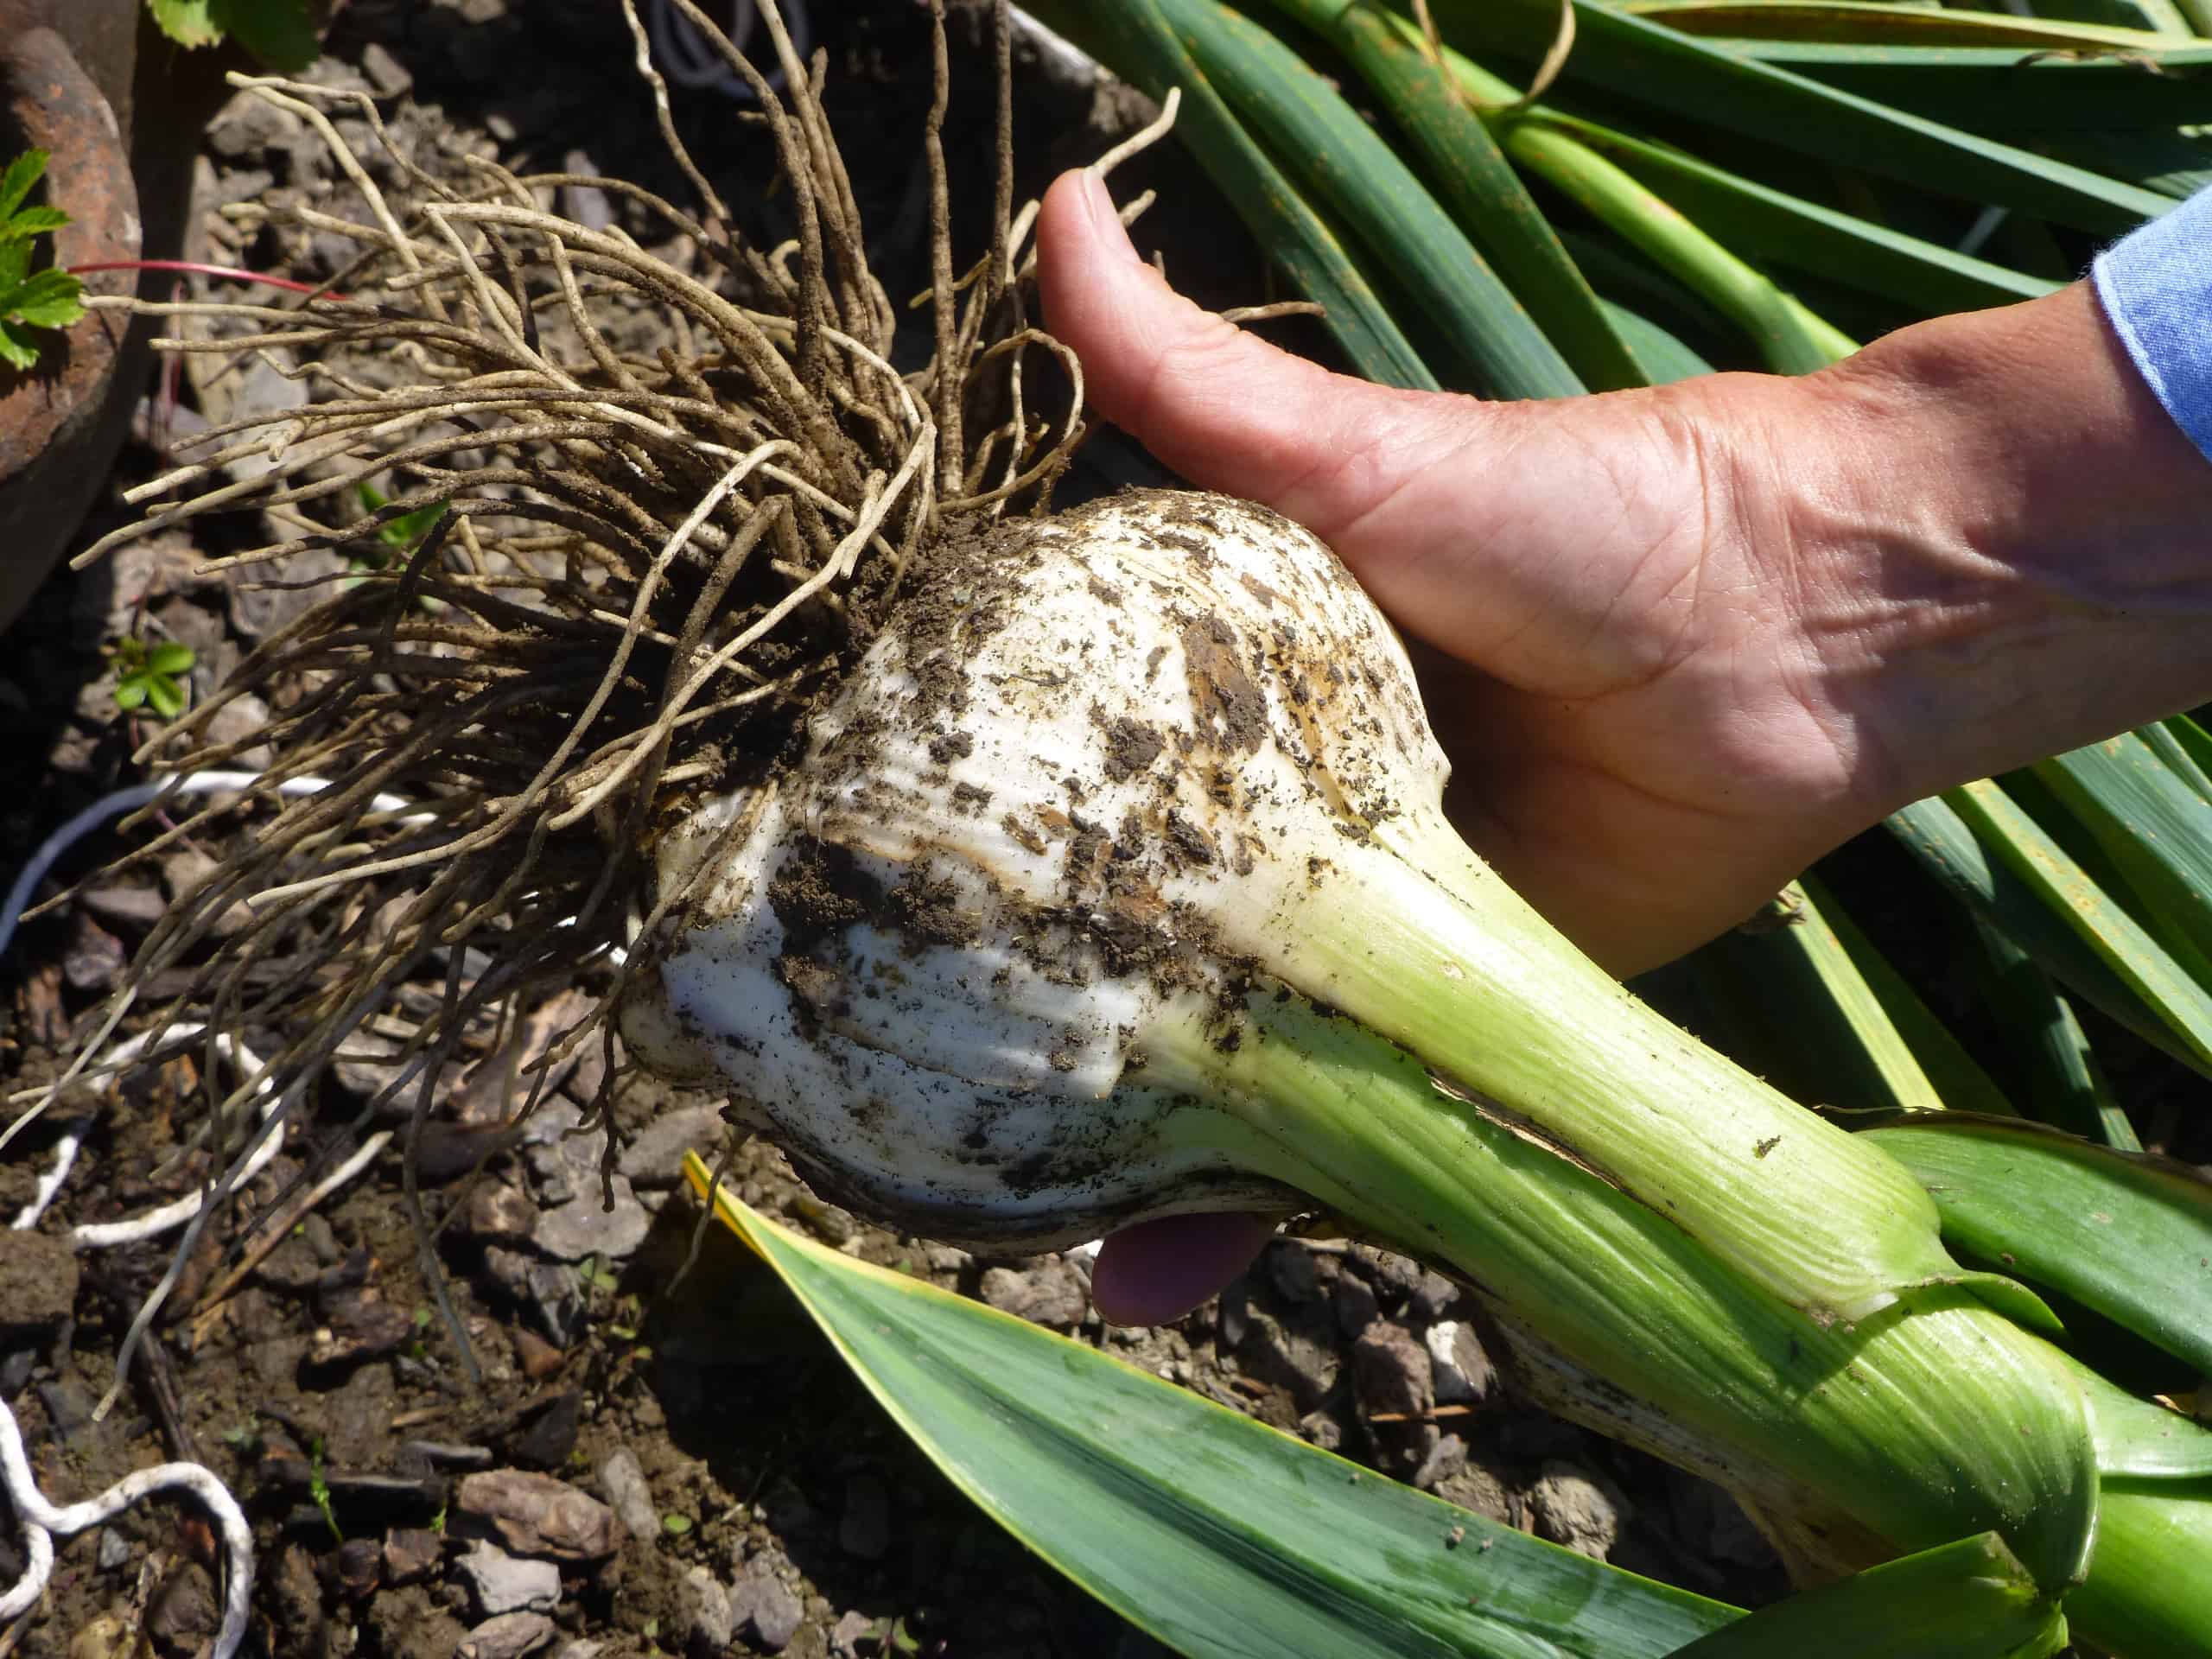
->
[1038, 173, 2212, 1323]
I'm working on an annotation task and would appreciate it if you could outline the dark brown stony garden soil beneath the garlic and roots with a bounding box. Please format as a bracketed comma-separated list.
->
[0, 0, 1781, 1659]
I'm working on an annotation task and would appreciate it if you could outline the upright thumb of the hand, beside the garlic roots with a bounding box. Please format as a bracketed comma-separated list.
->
[1038, 173, 1486, 559]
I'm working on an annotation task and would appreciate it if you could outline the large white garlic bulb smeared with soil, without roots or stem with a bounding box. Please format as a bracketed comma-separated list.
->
[624, 491, 1446, 1243]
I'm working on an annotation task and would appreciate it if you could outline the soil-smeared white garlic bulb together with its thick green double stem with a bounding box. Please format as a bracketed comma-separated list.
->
[624, 493, 2158, 1618]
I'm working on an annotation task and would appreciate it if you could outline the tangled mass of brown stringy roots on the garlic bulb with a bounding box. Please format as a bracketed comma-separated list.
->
[17, 0, 1173, 1407]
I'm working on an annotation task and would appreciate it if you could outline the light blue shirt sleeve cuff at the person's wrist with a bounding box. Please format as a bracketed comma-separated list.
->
[2090, 190, 2212, 460]
